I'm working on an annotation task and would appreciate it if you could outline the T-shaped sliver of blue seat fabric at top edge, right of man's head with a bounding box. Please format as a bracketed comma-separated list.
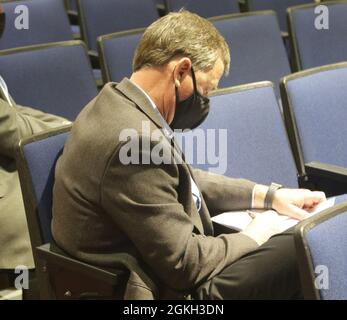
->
[247, 0, 313, 31]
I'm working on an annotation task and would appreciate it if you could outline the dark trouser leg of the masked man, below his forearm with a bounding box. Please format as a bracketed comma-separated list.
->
[193, 231, 302, 300]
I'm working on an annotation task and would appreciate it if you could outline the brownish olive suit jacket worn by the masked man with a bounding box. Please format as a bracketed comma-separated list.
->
[52, 78, 257, 299]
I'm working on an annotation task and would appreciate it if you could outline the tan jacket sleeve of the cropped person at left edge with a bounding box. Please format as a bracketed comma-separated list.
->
[0, 99, 70, 158]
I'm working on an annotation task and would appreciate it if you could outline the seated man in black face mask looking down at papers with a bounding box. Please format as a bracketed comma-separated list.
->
[52, 11, 325, 299]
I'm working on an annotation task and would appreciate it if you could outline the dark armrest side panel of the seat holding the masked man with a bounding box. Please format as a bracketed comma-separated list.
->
[35, 244, 129, 300]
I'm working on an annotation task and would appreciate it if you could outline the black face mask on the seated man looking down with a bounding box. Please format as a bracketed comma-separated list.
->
[170, 68, 210, 130]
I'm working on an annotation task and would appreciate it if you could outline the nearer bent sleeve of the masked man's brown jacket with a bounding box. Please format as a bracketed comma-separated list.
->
[100, 136, 257, 291]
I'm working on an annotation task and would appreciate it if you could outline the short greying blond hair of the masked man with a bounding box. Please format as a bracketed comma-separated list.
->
[133, 10, 230, 74]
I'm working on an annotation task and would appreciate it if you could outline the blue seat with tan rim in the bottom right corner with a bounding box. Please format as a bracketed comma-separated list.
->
[294, 199, 347, 300]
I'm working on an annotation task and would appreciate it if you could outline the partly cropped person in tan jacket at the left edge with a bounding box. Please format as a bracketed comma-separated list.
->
[0, 76, 70, 286]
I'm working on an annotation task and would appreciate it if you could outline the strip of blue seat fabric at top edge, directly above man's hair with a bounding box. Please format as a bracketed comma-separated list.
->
[167, 0, 239, 17]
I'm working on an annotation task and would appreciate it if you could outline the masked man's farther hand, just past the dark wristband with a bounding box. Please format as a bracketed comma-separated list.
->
[272, 188, 326, 220]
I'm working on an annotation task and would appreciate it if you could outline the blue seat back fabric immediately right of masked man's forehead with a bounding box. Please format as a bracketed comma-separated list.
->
[214, 14, 291, 95]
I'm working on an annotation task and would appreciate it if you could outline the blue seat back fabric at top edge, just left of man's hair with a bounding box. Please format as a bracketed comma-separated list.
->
[80, 0, 159, 50]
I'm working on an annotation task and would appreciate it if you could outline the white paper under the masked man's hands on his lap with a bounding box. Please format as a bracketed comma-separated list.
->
[212, 197, 335, 232]
